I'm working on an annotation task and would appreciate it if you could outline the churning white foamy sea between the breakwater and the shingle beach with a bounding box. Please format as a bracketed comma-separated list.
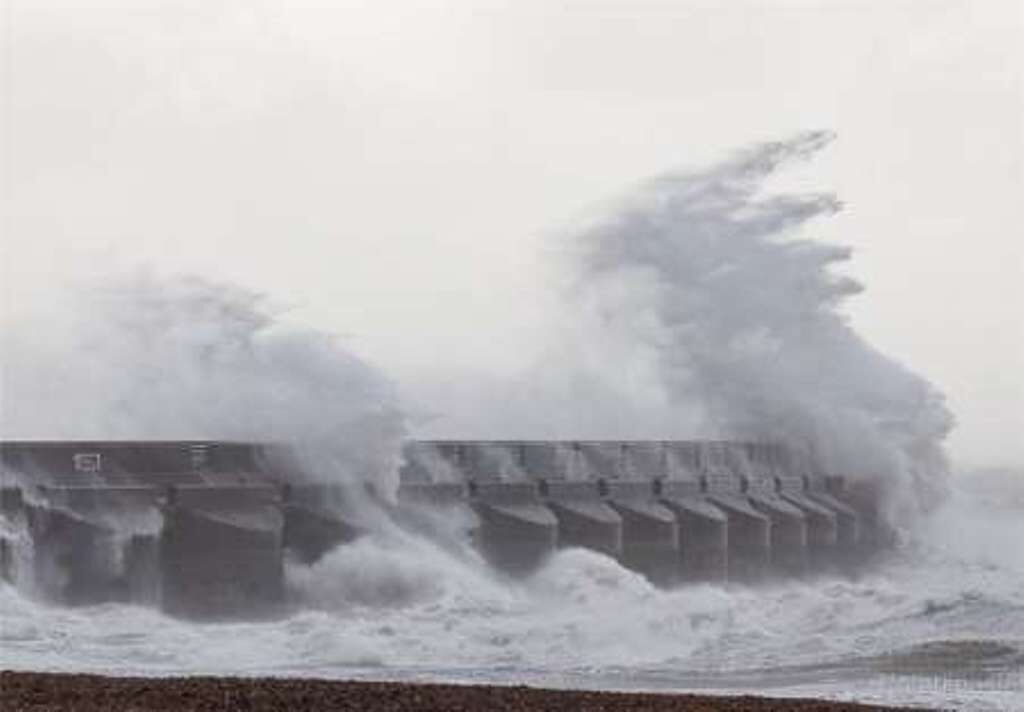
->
[0, 471, 1024, 709]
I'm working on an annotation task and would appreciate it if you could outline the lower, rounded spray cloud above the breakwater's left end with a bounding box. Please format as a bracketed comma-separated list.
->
[0, 271, 403, 493]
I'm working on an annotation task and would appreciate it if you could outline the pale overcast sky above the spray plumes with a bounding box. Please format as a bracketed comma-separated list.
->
[0, 0, 1024, 463]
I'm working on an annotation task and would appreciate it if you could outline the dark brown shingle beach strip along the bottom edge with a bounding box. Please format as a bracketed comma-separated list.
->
[0, 672, 929, 712]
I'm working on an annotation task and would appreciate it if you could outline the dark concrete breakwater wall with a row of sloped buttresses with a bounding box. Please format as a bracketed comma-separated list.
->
[0, 441, 891, 618]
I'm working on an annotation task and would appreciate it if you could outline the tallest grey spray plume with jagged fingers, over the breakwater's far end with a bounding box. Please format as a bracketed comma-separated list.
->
[577, 132, 951, 515]
